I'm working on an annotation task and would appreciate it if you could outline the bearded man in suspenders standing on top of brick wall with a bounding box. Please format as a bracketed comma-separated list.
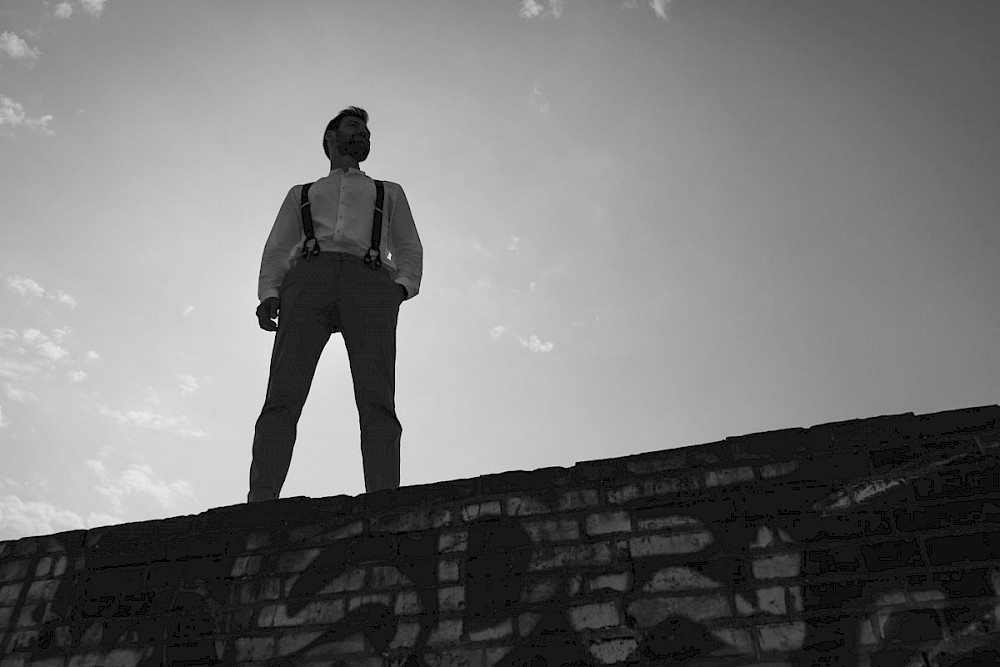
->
[247, 107, 423, 503]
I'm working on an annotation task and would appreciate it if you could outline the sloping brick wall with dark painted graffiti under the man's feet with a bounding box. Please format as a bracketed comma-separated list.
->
[0, 406, 1000, 667]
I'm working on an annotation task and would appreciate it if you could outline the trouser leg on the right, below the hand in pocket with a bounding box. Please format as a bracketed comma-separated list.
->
[340, 263, 403, 493]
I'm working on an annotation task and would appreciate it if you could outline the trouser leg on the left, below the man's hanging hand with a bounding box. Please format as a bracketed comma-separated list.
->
[247, 265, 332, 502]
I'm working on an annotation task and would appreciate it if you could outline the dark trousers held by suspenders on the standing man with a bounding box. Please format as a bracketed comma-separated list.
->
[247, 252, 403, 502]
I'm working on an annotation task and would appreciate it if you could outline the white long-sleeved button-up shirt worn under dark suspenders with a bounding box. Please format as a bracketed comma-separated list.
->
[257, 167, 424, 301]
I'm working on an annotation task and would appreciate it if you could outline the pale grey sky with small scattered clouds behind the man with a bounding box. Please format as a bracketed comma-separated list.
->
[0, 0, 1000, 539]
